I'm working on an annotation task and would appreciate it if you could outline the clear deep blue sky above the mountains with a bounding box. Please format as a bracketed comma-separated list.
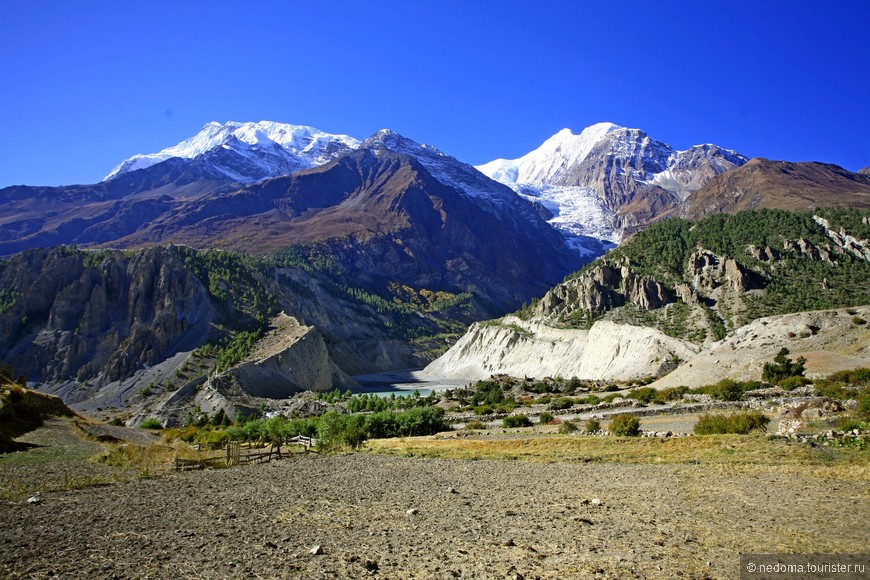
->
[0, 0, 870, 187]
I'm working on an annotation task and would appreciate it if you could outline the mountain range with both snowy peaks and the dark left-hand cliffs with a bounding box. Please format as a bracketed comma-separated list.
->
[0, 121, 870, 422]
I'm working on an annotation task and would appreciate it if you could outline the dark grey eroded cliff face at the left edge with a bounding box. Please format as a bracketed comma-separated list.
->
[0, 248, 213, 382]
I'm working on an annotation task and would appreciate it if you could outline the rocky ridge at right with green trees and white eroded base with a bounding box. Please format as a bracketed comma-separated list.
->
[426, 210, 870, 380]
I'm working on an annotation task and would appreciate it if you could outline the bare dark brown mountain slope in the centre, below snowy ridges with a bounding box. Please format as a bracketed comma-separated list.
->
[111, 149, 582, 313]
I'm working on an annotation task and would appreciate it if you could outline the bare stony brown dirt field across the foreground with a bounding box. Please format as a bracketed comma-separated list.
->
[0, 436, 870, 579]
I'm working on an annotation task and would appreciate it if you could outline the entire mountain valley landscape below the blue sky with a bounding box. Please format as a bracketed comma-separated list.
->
[0, 122, 870, 578]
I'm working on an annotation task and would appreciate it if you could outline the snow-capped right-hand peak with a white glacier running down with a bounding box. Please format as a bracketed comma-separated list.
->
[477, 123, 747, 243]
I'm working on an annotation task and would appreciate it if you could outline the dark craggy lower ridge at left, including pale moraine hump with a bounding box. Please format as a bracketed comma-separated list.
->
[0, 246, 470, 420]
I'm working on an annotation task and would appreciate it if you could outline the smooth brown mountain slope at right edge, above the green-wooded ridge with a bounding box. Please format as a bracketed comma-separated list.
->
[683, 158, 870, 219]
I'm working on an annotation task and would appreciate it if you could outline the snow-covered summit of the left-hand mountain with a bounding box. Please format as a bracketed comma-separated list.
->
[105, 121, 360, 183]
